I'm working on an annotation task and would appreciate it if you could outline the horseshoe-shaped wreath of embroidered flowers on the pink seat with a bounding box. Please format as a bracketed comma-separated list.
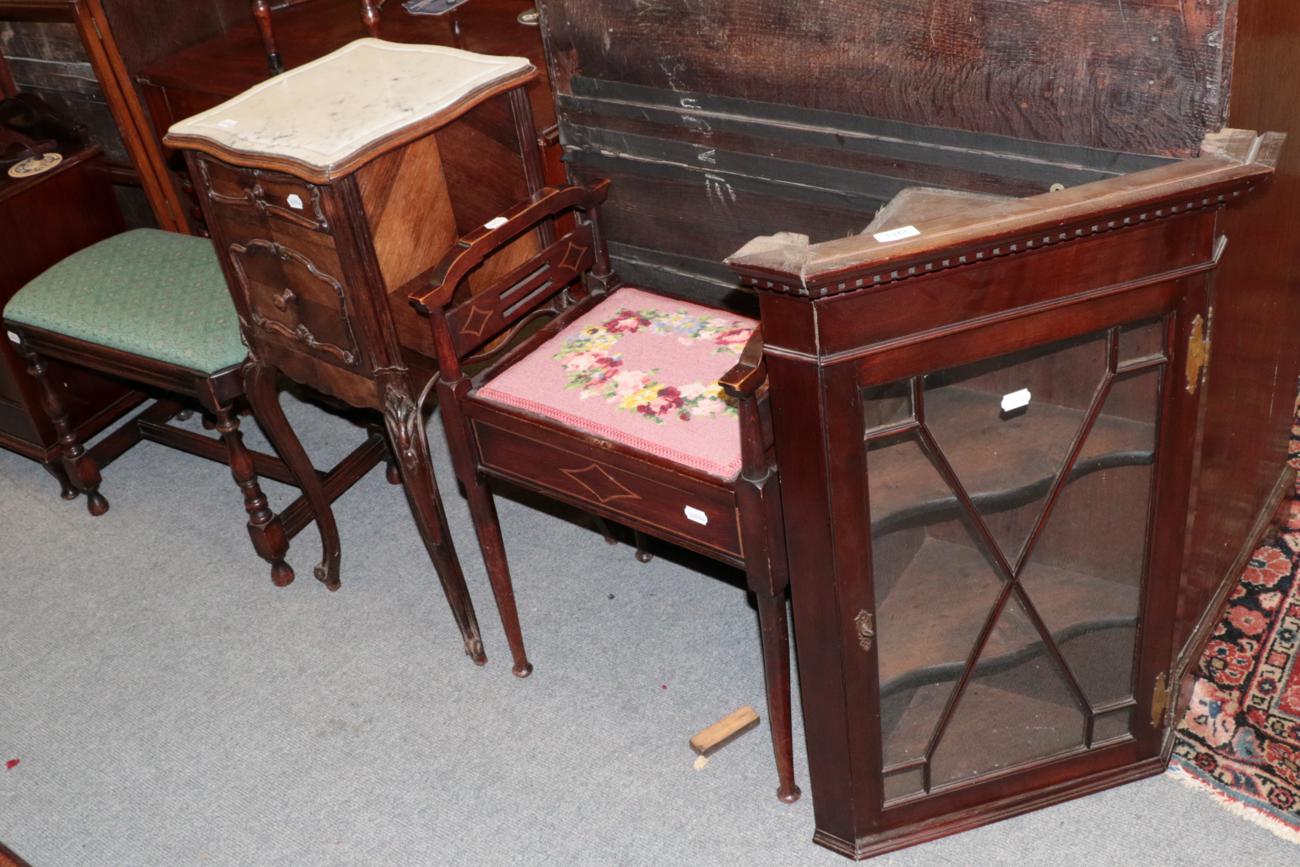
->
[551, 307, 754, 424]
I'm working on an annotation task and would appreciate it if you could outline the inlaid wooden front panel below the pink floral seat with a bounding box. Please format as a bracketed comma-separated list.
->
[473, 419, 742, 559]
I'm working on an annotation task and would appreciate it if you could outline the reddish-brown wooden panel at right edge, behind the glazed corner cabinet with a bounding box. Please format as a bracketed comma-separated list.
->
[1177, 0, 1300, 667]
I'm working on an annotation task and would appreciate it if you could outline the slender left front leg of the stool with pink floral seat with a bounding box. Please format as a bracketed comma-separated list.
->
[438, 378, 533, 677]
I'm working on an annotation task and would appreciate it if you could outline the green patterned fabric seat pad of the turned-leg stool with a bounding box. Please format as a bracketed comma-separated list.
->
[4, 229, 247, 373]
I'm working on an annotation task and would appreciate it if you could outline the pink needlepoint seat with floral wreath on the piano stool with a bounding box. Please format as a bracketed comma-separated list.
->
[477, 289, 758, 478]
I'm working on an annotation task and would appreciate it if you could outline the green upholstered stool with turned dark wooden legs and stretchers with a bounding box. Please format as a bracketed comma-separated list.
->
[4, 229, 385, 586]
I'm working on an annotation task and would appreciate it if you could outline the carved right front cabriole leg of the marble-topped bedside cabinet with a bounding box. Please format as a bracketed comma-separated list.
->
[384, 382, 488, 666]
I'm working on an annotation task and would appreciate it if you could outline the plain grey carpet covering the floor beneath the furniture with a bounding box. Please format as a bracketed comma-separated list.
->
[0, 400, 1296, 867]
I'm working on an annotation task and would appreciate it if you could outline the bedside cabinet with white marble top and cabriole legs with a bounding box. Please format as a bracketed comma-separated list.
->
[166, 39, 542, 673]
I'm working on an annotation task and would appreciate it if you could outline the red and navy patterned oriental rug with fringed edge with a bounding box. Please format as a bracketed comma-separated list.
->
[1170, 397, 1300, 844]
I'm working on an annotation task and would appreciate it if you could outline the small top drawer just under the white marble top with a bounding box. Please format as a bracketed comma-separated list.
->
[196, 157, 329, 234]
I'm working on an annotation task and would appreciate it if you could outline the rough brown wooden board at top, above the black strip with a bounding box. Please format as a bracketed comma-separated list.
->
[540, 0, 1236, 156]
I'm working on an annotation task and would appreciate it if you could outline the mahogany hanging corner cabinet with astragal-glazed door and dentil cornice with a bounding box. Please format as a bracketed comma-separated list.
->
[731, 142, 1281, 857]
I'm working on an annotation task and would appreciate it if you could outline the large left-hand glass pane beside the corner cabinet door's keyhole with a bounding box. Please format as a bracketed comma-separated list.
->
[867, 434, 1004, 767]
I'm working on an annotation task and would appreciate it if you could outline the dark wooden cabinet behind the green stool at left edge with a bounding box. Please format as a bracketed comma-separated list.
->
[0, 148, 143, 491]
